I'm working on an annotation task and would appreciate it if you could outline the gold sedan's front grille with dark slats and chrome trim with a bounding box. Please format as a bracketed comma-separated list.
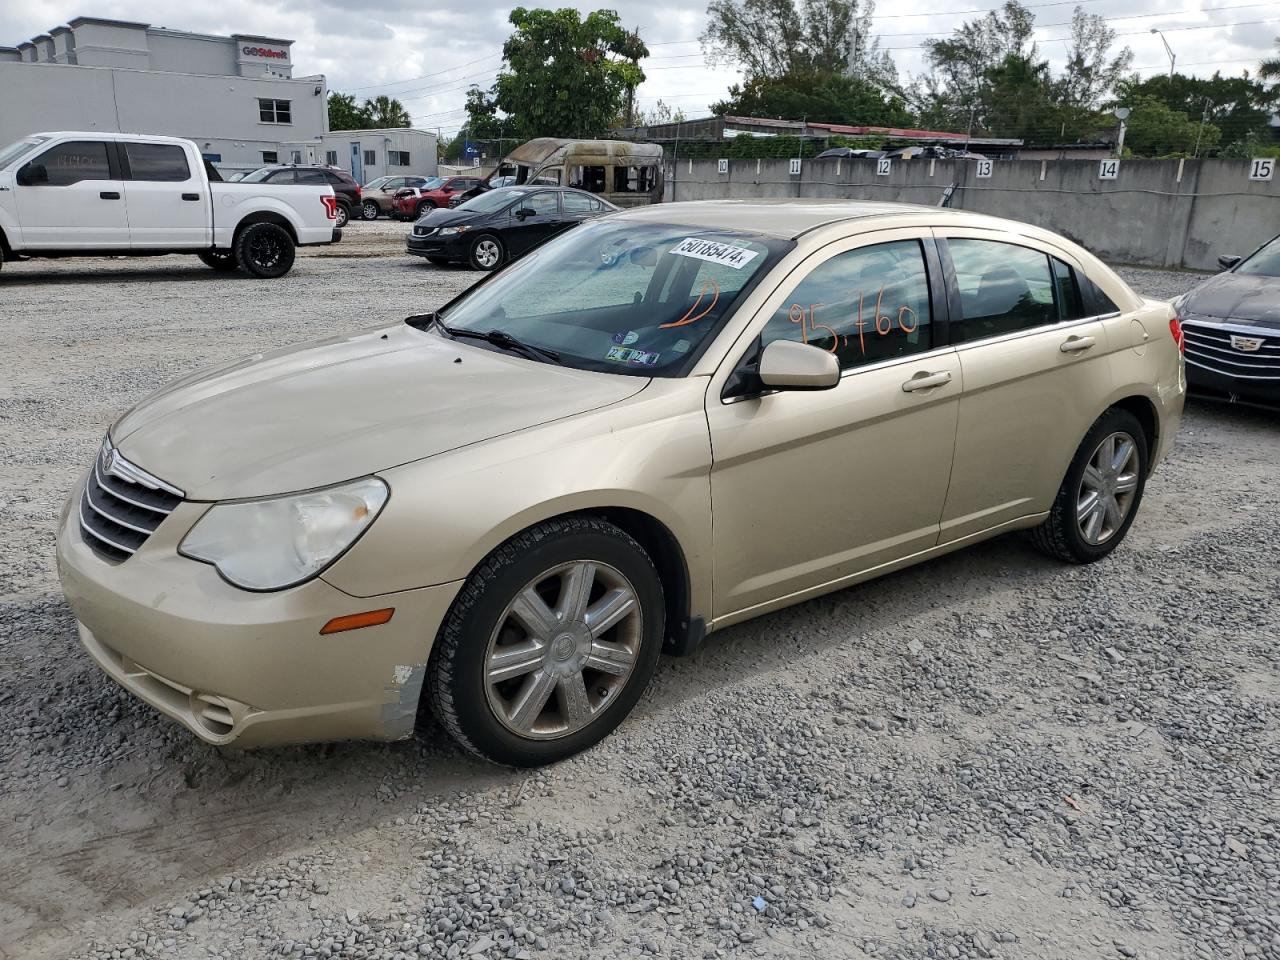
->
[79, 442, 182, 563]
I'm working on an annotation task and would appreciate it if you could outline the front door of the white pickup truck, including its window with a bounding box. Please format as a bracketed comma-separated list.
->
[14, 140, 129, 251]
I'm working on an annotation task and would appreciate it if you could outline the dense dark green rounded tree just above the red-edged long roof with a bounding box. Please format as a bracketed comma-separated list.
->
[712, 70, 911, 127]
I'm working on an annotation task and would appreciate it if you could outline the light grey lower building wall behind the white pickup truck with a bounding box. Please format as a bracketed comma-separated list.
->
[0, 61, 325, 169]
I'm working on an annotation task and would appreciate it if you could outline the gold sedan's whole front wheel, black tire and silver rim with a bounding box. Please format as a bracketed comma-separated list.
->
[426, 517, 666, 767]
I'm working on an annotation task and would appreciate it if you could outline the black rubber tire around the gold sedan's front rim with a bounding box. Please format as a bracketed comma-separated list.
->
[426, 517, 666, 767]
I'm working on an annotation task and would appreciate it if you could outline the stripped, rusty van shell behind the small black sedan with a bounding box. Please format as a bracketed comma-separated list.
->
[451, 137, 662, 207]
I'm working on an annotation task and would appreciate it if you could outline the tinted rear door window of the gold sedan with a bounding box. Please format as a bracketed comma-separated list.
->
[947, 238, 1065, 343]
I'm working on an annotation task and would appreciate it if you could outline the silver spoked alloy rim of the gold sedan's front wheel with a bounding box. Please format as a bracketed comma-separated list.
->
[484, 561, 644, 740]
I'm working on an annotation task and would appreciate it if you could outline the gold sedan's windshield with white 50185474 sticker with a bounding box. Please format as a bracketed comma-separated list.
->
[440, 220, 791, 376]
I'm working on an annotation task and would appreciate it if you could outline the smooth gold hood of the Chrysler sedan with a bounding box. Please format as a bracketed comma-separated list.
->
[111, 325, 649, 500]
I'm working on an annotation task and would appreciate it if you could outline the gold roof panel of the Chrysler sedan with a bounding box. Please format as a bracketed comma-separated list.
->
[617, 198, 1005, 239]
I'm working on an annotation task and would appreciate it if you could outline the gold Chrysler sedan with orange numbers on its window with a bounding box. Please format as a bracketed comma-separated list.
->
[58, 201, 1185, 765]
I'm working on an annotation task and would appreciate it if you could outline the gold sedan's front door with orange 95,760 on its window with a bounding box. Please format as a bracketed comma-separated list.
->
[707, 229, 961, 618]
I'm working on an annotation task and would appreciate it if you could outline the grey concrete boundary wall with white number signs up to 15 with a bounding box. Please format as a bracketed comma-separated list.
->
[664, 159, 1280, 270]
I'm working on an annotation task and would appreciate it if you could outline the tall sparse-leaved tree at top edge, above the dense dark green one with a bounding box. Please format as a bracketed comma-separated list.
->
[701, 0, 897, 90]
